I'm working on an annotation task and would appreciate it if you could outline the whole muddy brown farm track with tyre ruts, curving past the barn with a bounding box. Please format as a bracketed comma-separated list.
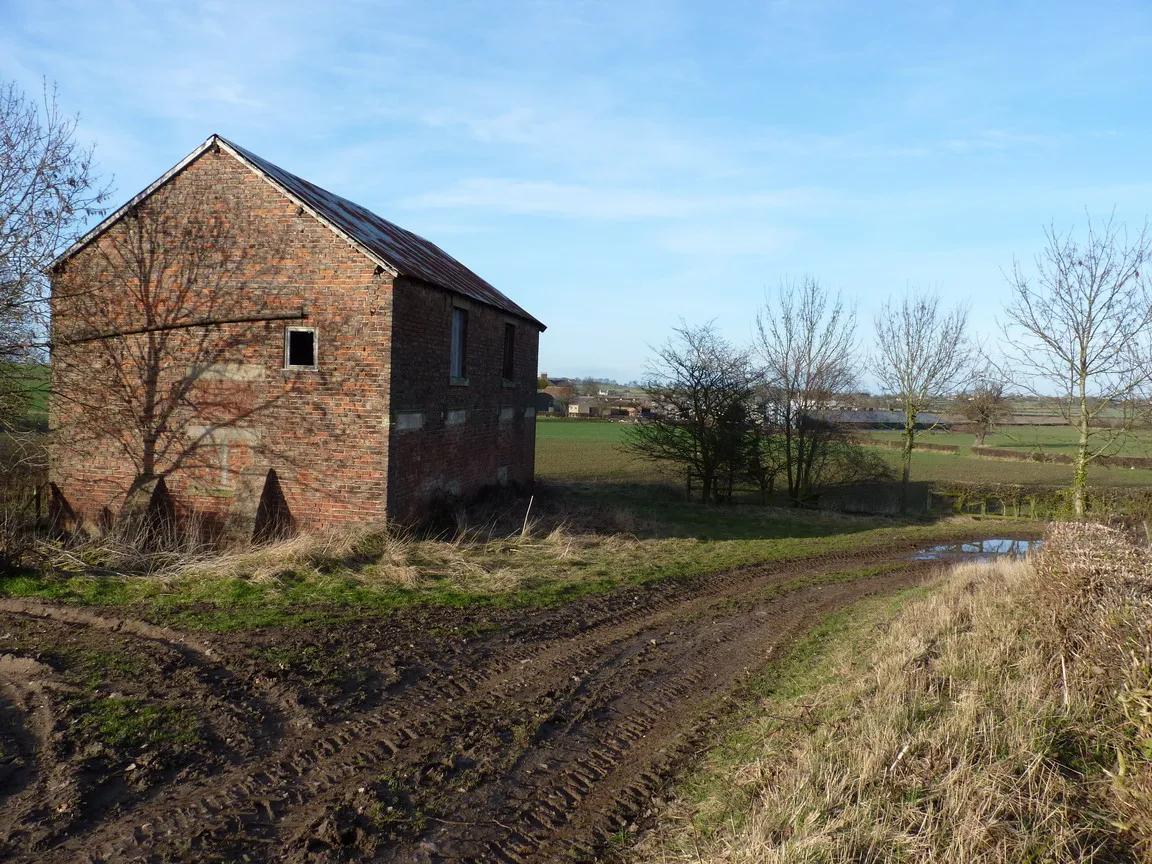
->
[0, 532, 1032, 863]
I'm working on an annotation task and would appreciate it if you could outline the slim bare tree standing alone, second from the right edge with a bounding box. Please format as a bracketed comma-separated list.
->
[872, 290, 970, 509]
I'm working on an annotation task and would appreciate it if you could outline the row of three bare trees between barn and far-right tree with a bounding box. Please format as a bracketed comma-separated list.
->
[626, 276, 953, 505]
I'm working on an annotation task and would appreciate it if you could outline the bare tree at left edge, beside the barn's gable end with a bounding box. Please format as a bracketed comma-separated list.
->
[0, 83, 109, 427]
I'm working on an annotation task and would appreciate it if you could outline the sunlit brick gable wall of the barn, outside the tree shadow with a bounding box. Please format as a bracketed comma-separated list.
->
[51, 145, 393, 526]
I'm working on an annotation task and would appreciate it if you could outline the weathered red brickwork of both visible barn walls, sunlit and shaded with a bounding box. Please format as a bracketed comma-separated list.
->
[51, 142, 539, 526]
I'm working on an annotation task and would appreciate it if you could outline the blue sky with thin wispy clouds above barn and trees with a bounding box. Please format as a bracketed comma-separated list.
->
[0, 0, 1152, 380]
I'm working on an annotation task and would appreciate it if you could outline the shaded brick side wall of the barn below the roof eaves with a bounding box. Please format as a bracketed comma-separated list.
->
[388, 279, 539, 520]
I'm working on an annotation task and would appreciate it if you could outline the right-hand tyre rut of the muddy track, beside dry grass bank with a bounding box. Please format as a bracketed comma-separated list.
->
[385, 568, 927, 862]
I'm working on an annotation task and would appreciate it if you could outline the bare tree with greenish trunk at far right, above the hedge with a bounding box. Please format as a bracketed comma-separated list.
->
[1003, 217, 1152, 517]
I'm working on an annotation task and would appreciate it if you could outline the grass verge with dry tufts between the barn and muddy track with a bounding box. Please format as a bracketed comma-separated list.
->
[0, 500, 1018, 629]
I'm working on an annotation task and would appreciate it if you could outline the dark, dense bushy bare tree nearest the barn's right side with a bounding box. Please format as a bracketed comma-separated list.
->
[624, 324, 756, 503]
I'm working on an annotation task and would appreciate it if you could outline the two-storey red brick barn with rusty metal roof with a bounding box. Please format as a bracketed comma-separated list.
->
[51, 136, 544, 536]
